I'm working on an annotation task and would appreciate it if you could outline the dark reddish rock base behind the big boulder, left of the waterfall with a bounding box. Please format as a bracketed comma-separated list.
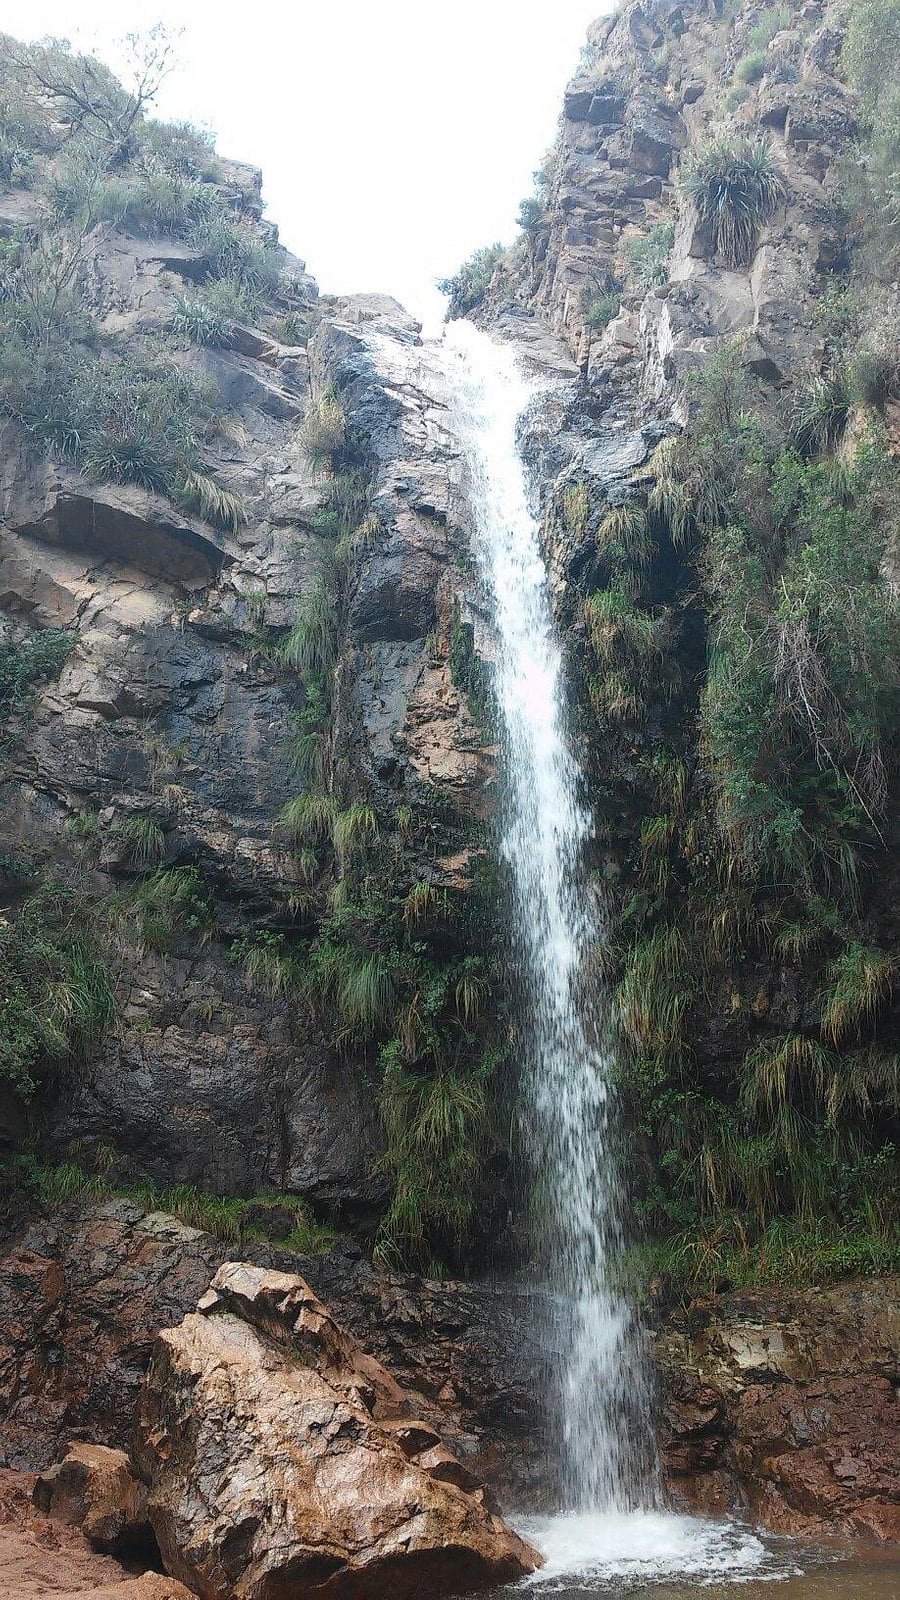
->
[0, 1200, 549, 1499]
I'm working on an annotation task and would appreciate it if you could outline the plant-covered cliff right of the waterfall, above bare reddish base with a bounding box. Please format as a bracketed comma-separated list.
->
[464, 3, 900, 1286]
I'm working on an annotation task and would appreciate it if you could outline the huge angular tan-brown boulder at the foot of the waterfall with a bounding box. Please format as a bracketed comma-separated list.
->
[136, 1262, 540, 1600]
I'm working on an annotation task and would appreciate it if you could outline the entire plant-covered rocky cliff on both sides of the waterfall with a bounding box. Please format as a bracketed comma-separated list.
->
[0, 0, 900, 1534]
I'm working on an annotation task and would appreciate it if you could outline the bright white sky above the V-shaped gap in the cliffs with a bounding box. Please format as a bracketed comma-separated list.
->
[0, 0, 612, 322]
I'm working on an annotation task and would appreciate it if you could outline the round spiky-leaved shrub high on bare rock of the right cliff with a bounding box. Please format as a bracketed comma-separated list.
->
[682, 139, 785, 267]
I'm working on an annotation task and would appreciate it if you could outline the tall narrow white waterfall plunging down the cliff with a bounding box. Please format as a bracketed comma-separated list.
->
[444, 323, 655, 1512]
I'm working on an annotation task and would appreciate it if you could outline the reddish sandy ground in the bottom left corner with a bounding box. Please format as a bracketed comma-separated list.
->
[0, 1467, 187, 1600]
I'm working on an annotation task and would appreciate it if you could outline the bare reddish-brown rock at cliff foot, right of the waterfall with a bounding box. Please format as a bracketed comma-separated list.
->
[658, 1278, 900, 1541]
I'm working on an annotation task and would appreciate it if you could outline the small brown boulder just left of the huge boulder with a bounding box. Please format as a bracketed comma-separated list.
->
[34, 1445, 152, 1555]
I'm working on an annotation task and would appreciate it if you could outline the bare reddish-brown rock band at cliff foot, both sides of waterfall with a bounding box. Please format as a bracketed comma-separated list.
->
[0, 1200, 900, 1541]
